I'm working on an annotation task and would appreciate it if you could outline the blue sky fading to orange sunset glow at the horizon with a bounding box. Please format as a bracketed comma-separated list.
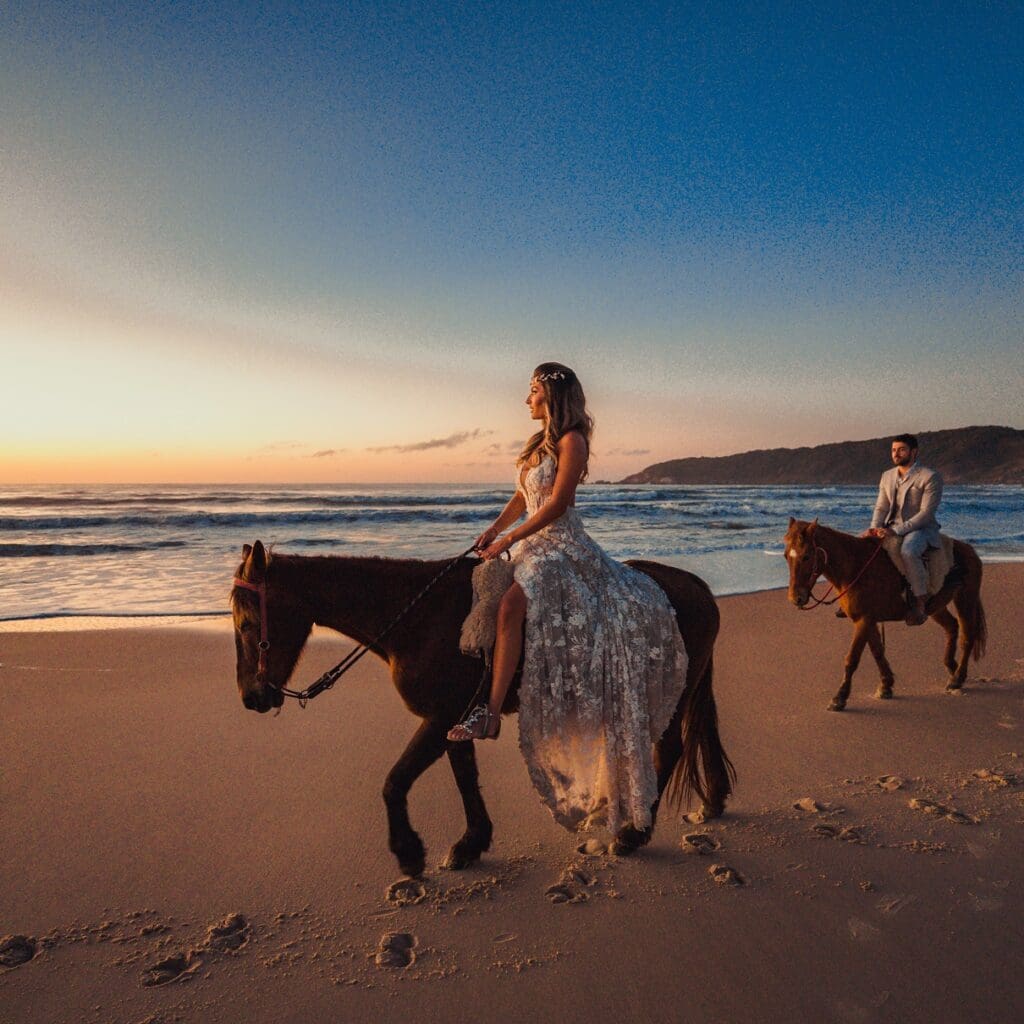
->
[0, 0, 1024, 484]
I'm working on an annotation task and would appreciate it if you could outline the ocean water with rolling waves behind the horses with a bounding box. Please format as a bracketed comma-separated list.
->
[0, 484, 1024, 620]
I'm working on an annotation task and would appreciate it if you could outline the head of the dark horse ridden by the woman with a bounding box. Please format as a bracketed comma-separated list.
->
[231, 541, 313, 714]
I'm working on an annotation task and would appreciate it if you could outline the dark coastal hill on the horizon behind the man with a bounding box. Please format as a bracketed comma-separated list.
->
[621, 427, 1024, 484]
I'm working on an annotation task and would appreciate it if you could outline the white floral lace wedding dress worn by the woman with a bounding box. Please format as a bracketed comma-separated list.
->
[512, 457, 687, 833]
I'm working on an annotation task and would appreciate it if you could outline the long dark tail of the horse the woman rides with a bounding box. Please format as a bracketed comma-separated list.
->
[665, 654, 736, 815]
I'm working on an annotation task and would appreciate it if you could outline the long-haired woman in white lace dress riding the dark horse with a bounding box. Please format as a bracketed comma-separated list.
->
[449, 362, 686, 833]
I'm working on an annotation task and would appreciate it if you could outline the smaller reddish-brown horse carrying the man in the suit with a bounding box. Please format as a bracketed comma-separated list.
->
[784, 519, 988, 711]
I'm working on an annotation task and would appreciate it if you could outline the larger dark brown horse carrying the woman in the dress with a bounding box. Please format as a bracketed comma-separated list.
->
[231, 541, 735, 876]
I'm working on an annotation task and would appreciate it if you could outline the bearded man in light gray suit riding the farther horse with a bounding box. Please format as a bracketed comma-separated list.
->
[863, 434, 942, 626]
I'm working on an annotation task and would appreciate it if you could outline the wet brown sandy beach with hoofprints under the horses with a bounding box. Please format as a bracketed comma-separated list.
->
[0, 564, 1024, 1024]
